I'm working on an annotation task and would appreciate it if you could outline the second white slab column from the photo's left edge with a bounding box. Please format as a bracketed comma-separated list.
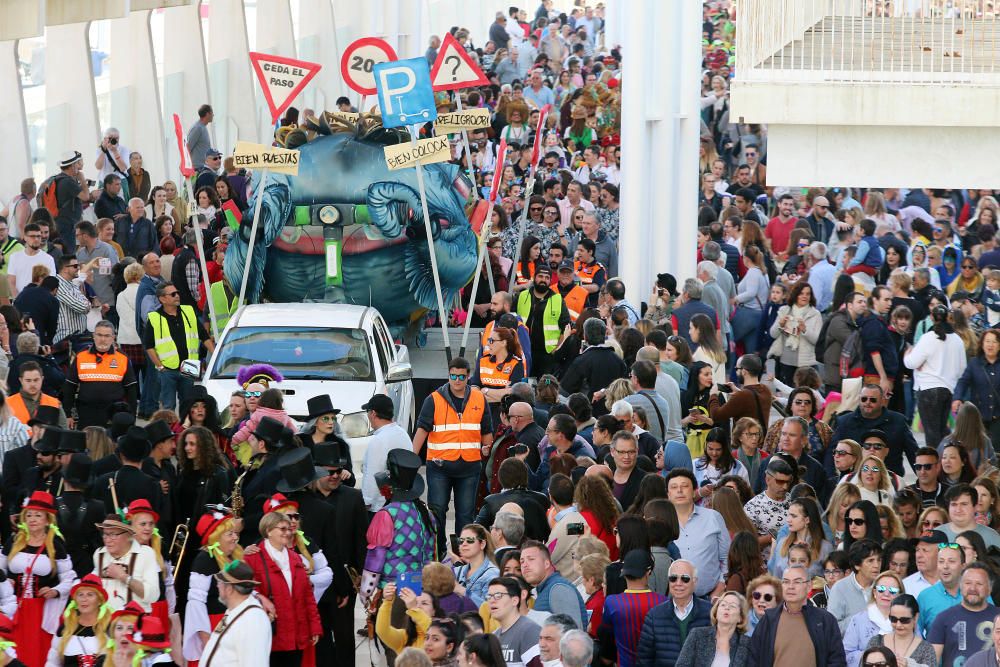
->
[45, 23, 101, 174]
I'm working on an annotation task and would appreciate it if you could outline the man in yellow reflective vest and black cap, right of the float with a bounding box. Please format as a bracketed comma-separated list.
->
[517, 264, 569, 377]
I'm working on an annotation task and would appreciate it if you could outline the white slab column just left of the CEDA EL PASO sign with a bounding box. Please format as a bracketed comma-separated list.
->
[208, 0, 258, 155]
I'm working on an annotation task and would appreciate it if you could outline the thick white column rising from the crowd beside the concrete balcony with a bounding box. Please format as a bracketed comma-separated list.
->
[616, 0, 701, 303]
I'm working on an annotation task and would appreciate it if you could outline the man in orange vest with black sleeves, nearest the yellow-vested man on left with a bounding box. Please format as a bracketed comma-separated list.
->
[63, 320, 139, 429]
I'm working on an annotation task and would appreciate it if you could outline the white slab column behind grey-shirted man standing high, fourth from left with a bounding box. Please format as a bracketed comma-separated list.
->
[163, 1, 212, 180]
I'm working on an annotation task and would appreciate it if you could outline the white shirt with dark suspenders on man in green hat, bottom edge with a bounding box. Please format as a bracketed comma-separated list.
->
[202, 596, 271, 667]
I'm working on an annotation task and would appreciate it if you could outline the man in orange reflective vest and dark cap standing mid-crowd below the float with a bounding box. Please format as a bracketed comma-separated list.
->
[413, 358, 494, 553]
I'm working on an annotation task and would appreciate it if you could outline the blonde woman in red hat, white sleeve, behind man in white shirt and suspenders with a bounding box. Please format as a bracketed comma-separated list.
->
[184, 512, 243, 661]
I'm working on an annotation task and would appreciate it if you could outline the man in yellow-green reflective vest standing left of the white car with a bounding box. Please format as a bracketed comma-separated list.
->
[142, 283, 215, 410]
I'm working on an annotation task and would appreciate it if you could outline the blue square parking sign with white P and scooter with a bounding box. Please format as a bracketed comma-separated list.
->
[374, 58, 437, 127]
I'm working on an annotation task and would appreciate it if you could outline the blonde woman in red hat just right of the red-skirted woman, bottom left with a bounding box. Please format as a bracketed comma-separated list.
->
[45, 574, 111, 667]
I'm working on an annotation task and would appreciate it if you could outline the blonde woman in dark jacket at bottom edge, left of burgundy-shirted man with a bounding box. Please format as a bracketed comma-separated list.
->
[676, 591, 750, 667]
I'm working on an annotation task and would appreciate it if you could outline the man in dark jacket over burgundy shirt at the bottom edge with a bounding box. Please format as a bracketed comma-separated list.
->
[747, 566, 847, 667]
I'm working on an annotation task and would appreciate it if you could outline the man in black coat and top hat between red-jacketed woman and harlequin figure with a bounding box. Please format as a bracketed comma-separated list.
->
[313, 443, 368, 665]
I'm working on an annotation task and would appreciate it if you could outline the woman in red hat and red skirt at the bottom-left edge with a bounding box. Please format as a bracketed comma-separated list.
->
[0, 491, 76, 667]
